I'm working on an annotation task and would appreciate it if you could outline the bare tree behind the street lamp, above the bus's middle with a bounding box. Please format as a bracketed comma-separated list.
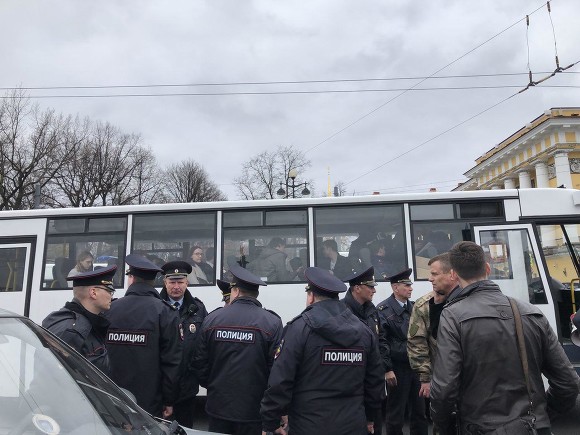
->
[234, 146, 311, 199]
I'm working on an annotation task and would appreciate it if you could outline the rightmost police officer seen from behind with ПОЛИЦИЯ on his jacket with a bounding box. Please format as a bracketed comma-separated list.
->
[261, 267, 384, 435]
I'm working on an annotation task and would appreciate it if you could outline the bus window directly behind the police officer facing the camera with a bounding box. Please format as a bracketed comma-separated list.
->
[131, 212, 217, 285]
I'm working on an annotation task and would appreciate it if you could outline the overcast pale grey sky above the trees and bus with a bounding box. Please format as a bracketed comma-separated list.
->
[0, 0, 580, 199]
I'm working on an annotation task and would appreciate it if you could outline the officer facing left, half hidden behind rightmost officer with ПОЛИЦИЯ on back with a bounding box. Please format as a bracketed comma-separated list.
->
[342, 266, 389, 435]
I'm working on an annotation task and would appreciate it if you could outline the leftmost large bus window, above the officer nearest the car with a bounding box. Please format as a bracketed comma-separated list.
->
[42, 216, 127, 290]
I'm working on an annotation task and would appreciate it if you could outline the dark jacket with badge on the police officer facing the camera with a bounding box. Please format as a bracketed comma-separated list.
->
[160, 289, 207, 402]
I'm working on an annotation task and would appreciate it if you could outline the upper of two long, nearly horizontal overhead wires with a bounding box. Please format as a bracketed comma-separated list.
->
[0, 71, 579, 91]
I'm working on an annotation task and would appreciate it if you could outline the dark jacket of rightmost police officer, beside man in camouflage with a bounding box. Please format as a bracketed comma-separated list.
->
[377, 295, 414, 371]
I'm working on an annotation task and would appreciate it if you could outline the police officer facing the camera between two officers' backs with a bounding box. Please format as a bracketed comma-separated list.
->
[161, 261, 207, 427]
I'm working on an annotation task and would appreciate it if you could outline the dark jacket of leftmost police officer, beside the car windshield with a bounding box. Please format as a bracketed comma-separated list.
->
[42, 299, 111, 375]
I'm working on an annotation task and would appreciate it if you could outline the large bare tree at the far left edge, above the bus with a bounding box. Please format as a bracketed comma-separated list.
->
[0, 90, 79, 210]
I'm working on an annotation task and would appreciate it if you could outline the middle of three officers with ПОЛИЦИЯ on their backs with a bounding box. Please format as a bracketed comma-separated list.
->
[193, 265, 282, 435]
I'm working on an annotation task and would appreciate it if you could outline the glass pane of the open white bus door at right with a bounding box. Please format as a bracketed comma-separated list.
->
[480, 229, 548, 304]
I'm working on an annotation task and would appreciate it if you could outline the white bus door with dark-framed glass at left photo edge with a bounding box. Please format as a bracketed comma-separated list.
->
[0, 237, 36, 316]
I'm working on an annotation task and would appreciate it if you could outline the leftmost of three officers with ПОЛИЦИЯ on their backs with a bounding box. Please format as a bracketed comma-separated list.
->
[107, 254, 182, 418]
